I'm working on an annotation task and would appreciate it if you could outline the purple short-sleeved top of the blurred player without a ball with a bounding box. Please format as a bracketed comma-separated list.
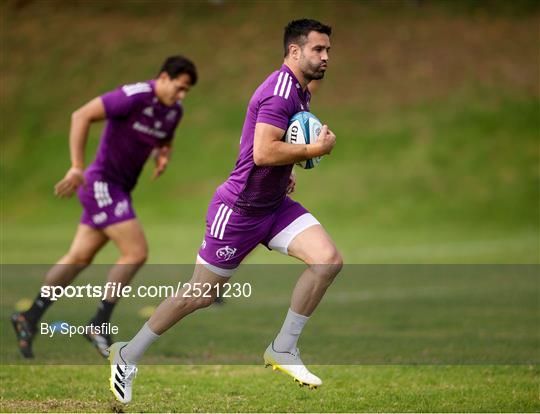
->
[86, 80, 183, 192]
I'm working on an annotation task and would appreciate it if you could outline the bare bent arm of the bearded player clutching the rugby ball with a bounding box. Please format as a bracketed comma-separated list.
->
[253, 122, 336, 167]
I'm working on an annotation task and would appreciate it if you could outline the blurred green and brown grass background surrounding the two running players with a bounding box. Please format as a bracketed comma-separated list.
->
[0, 1, 540, 412]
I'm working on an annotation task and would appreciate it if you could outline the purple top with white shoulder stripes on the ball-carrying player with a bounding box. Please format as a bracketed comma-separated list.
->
[217, 65, 311, 215]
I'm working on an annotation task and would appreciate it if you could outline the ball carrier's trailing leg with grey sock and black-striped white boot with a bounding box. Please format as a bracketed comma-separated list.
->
[109, 263, 228, 403]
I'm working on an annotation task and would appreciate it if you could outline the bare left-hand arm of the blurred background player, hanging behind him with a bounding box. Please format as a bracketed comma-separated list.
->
[54, 97, 106, 197]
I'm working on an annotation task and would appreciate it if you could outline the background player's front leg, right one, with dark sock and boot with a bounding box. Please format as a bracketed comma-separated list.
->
[85, 218, 148, 357]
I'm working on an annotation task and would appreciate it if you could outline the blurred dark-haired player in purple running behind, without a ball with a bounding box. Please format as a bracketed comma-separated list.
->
[11, 56, 197, 358]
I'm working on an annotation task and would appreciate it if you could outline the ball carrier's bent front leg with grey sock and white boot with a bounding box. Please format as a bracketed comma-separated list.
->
[264, 225, 343, 388]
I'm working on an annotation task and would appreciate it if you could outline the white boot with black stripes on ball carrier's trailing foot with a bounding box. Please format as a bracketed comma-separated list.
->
[109, 342, 137, 404]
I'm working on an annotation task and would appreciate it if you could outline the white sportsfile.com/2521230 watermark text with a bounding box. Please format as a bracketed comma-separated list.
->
[40, 282, 252, 301]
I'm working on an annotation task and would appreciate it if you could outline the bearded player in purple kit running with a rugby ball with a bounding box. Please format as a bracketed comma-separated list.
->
[109, 19, 342, 403]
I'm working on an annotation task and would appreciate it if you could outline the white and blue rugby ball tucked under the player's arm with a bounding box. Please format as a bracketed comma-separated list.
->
[285, 111, 322, 170]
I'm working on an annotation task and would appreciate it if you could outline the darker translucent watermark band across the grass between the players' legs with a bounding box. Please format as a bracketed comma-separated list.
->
[0, 265, 540, 366]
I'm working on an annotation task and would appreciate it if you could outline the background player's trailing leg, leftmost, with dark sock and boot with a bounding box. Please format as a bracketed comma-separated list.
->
[11, 224, 108, 358]
